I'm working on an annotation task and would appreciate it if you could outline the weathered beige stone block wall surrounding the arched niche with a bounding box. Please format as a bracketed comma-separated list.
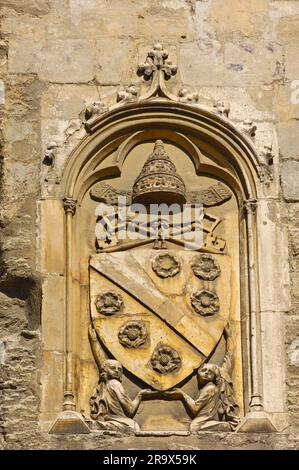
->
[0, 0, 299, 448]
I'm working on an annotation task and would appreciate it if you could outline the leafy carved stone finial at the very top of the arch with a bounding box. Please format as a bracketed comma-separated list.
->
[137, 43, 177, 80]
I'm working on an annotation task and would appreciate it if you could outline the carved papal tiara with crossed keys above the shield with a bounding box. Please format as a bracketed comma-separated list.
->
[90, 140, 232, 253]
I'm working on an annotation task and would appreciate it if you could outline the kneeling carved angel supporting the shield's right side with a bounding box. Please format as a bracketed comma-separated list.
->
[167, 324, 239, 432]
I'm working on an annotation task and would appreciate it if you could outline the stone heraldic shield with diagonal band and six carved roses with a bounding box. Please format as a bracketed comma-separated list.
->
[90, 248, 231, 391]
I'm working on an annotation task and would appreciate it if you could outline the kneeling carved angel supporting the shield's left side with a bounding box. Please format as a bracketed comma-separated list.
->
[88, 325, 152, 431]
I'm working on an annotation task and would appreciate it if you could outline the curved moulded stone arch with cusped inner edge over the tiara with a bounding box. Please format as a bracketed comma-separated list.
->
[61, 98, 259, 204]
